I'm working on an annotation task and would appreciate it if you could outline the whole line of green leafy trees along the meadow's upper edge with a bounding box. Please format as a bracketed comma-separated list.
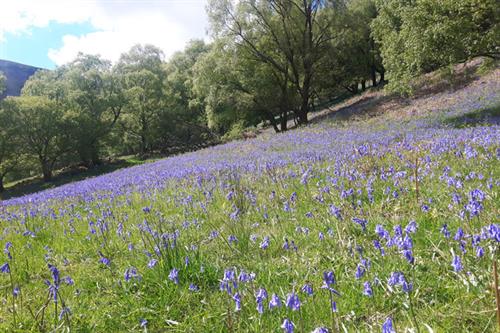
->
[0, 0, 500, 191]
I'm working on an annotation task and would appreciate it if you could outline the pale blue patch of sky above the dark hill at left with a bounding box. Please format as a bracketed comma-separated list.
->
[0, 22, 96, 69]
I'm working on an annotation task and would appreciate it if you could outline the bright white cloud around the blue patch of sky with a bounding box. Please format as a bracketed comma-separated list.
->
[0, 0, 207, 65]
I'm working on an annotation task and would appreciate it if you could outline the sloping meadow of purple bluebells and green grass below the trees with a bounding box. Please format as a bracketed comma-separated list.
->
[0, 79, 500, 333]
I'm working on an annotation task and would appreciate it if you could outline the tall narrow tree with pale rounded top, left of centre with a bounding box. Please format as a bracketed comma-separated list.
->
[116, 45, 166, 154]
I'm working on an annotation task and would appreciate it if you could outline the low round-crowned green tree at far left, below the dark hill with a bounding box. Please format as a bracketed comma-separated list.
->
[3, 96, 69, 181]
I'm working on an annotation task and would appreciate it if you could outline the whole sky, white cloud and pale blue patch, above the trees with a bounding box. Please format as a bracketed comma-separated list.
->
[0, 0, 208, 69]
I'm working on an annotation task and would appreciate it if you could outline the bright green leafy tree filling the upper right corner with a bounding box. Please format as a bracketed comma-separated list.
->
[372, 0, 500, 93]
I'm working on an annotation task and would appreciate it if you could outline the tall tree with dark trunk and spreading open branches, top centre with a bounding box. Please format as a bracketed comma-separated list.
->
[208, 0, 335, 124]
